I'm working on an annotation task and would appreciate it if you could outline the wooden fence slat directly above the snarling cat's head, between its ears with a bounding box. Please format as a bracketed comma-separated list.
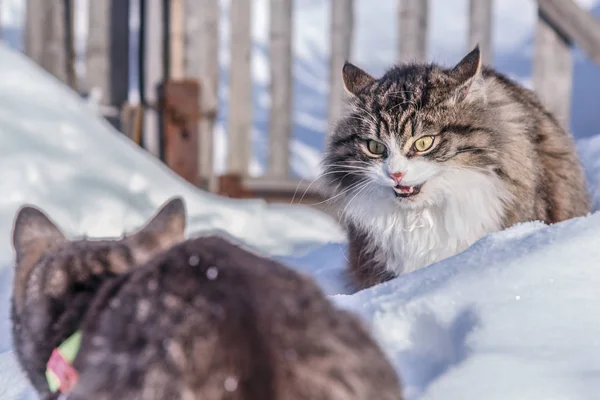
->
[398, 0, 429, 62]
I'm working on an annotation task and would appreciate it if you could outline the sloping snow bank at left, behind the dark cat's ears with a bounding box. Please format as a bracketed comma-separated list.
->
[0, 43, 343, 265]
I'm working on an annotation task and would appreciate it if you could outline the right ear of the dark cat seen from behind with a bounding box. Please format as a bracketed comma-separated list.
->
[130, 197, 186, 262]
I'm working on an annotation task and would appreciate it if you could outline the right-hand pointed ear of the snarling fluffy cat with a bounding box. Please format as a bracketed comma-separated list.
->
[449, 45, 485, 103]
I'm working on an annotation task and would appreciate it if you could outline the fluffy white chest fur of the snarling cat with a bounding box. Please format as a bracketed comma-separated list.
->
[346, 171, 510, 275]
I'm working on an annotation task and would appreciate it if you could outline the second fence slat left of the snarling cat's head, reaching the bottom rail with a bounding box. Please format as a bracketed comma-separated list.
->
[267, 0, 293, 178]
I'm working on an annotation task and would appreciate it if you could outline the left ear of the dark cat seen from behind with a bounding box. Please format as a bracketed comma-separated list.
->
[12, 206, 66, 268]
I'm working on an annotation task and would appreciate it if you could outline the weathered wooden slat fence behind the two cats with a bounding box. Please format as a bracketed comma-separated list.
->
[7, 0, 600, 206]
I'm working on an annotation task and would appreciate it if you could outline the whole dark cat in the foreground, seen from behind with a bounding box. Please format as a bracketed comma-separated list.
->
[13, 202, 402, 400]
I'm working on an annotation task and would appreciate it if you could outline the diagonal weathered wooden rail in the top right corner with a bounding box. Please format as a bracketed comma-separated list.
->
[538, 0, 600, 66]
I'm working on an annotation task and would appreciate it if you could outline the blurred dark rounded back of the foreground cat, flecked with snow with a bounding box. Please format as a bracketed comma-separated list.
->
[77, 237, 401, 400]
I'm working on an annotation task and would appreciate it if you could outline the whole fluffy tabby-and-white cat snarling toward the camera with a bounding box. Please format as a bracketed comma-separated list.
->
[322, 46, 590, 288]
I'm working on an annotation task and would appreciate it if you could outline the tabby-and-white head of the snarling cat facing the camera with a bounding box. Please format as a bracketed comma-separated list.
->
[321, 47, 499, 219]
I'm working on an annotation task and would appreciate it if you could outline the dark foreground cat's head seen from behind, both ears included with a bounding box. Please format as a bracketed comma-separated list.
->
[12, 198, 186, 389]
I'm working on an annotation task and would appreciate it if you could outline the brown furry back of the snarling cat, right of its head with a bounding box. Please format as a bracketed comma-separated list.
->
[483, 68, 591, 224]
